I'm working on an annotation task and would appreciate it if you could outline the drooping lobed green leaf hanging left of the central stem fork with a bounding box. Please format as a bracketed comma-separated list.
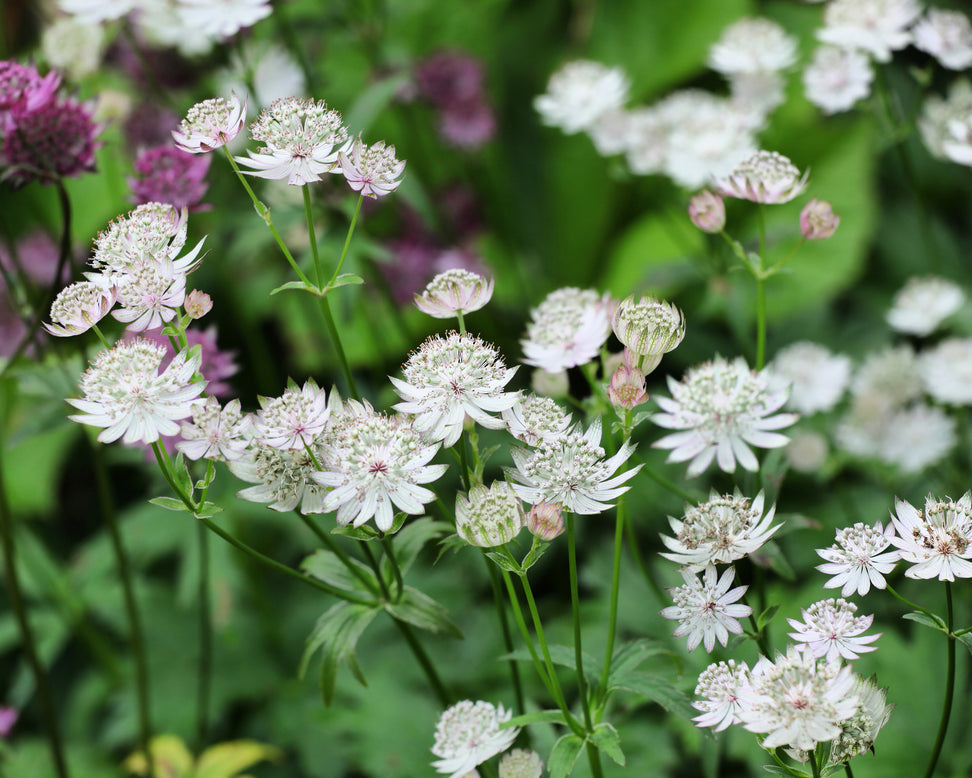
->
[297, 602, 379, 705]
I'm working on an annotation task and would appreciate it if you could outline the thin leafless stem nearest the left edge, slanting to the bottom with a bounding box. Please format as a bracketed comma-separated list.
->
[0, 442, 70, 778]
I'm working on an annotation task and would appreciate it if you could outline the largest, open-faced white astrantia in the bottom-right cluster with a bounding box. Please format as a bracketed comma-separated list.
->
[739, 645, 860, 751]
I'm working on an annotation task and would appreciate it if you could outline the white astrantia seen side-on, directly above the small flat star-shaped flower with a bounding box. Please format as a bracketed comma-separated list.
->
[661, 491, 781, 567]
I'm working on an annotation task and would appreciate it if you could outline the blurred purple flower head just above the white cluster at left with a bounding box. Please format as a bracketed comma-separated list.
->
[128, 146, 212, 210]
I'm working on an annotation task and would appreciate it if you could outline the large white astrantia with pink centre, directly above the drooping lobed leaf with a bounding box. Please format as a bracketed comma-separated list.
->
[312, 403, 446, 532]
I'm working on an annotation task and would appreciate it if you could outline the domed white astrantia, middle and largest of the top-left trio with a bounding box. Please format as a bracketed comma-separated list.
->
[236, 97, 353, 186]
